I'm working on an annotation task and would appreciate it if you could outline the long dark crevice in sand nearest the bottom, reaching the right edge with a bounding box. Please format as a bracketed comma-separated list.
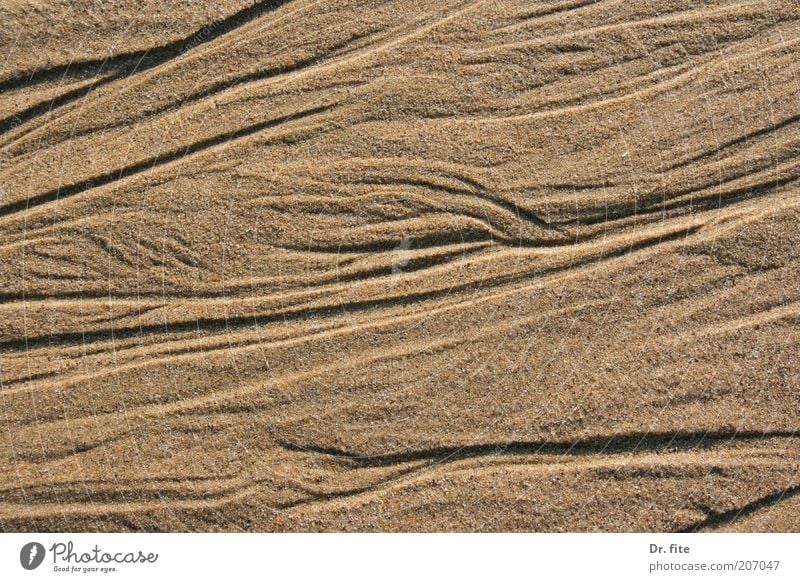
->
[276, 429, 800, 467]
